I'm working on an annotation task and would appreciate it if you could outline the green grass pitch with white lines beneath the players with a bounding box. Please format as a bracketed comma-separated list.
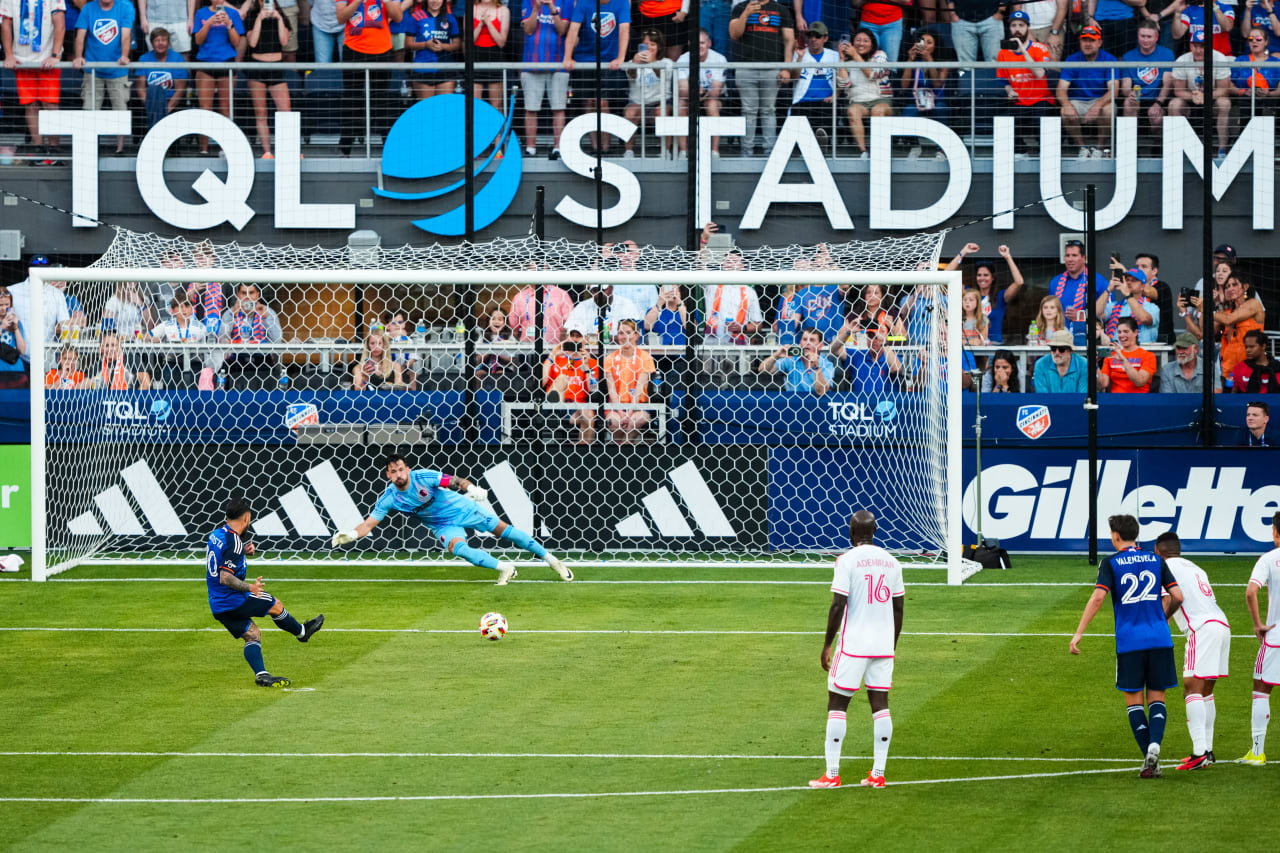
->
[0, 556, 1280, 853]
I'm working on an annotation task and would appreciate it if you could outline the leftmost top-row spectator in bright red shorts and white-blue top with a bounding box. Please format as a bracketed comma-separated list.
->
[0, 0, 67, 164]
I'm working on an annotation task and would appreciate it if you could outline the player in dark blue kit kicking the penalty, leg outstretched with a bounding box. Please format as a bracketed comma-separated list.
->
[205, 498, 324, 688]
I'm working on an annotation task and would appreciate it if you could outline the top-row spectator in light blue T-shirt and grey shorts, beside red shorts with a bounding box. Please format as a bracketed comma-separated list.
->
[72, 0, 133, 154]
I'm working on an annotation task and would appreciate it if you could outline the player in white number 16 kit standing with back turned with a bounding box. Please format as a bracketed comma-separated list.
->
[809, 510, 906, 788]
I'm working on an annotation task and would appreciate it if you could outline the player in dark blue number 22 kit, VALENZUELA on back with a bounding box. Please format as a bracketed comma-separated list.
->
[1070, 515, 1183, 779]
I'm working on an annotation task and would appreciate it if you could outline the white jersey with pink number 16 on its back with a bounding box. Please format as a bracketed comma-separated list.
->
[831, 546, 906, 657]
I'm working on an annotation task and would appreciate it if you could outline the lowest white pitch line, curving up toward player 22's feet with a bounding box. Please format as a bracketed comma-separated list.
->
[0, 762, 1137, 806]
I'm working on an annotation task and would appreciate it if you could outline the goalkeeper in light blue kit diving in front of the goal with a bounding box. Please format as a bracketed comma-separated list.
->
[333, 453, 573, 587]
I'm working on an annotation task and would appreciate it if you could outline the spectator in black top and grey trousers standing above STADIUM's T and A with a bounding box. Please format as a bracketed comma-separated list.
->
[728, 0, 796, 156]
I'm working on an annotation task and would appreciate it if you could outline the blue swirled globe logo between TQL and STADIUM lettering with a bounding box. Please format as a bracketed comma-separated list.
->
[372, 95, 522, 237]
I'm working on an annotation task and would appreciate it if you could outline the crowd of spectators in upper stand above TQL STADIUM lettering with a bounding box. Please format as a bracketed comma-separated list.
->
[0, 0, 1280, 164]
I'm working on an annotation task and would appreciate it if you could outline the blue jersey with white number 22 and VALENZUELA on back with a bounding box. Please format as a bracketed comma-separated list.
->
[1097, 548, 1178, 654]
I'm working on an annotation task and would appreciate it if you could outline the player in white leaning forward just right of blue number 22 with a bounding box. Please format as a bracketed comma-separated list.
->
[1156, 530, 1231, 770]
